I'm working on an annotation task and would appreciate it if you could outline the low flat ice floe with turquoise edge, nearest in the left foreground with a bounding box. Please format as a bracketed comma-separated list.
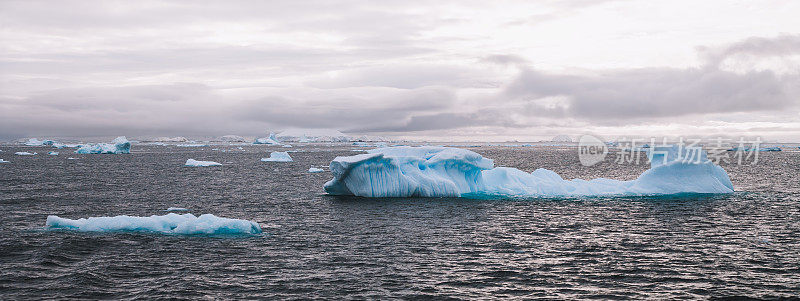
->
[46, 213, 261, 235]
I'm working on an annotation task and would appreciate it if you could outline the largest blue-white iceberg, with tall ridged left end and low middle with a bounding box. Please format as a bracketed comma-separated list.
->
[324, 146, 733, 197]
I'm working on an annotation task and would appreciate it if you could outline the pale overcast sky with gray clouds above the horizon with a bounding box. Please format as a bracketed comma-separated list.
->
[0, 0, 800, 142]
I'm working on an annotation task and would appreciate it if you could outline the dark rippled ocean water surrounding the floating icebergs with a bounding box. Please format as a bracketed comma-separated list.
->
[0, 145, 800, 300]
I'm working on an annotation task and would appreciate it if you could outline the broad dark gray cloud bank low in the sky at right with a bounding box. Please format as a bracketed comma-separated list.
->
[506, 68, 800, 121]
